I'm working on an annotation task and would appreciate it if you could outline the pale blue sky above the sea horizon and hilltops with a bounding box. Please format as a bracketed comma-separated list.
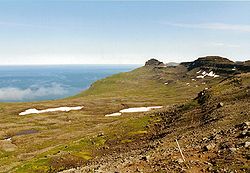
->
[0, 0, 250, 65]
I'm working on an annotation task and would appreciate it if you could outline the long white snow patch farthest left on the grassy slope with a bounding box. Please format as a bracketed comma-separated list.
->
[19, 106, 83, 115]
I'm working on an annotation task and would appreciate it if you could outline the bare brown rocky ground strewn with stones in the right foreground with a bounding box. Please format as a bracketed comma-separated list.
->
[63, 73, 250, 173]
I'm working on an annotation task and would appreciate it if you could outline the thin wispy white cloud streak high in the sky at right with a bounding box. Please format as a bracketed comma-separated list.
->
[162, 22, 250, 32]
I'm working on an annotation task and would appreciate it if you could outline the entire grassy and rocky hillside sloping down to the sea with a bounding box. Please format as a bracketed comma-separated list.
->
[0, 57, 250, 172]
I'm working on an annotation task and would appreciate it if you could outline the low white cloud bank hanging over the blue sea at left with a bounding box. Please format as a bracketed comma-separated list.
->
[0, 83, 66, 101]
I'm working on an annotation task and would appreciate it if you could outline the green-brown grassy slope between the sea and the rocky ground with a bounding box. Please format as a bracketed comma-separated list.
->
[0, 67, 217, 172]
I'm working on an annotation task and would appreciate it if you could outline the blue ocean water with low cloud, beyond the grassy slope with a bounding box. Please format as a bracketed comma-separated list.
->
[0, 65, 139, 102]
